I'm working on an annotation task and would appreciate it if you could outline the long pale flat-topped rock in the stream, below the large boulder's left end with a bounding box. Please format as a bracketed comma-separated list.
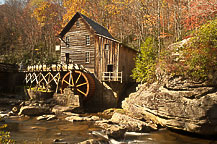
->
[111, 113, 157, 132]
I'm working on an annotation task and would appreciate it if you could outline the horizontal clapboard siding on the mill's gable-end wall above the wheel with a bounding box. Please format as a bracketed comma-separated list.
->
[61, 18, 95, 72]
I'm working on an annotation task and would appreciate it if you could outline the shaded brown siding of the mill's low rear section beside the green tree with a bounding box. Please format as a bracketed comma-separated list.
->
[118, 45, 136, 81]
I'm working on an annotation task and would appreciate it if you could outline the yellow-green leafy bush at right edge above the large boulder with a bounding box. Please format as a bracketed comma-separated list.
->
[184, 19, 217, 80]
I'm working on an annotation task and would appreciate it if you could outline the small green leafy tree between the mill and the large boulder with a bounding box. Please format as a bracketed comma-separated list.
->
[132, 37, 157, 82]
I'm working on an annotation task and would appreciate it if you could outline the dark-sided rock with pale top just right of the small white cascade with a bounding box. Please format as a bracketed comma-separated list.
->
[95, 120, 127, 139]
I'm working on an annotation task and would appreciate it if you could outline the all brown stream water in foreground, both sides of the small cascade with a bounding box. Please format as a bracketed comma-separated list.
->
[2, 117, 217, 144]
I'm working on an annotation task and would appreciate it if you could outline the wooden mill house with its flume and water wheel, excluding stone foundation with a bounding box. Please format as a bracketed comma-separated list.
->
[26, 12, 137, 102]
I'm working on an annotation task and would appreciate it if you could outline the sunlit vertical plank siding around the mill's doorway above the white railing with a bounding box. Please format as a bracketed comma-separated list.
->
[95, 36, 119, 80]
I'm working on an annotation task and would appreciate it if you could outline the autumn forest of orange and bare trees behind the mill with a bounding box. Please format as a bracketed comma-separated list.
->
[0, 0, 217, 81]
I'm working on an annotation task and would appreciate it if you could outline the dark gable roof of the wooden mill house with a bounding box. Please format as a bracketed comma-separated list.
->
[59, 12, 115, 40]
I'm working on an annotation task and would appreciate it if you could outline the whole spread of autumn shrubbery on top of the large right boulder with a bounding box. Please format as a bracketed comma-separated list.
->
[160, 19, 217, 81]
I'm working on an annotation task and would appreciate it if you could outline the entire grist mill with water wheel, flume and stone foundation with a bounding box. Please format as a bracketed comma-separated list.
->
[25, 13, 137, 109]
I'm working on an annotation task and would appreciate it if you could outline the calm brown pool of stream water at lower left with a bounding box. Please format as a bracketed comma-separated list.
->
[6, 118, 102, 144]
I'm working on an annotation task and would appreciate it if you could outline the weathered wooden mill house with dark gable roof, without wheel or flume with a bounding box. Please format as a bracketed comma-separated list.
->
[59, 12, 137, 82]
